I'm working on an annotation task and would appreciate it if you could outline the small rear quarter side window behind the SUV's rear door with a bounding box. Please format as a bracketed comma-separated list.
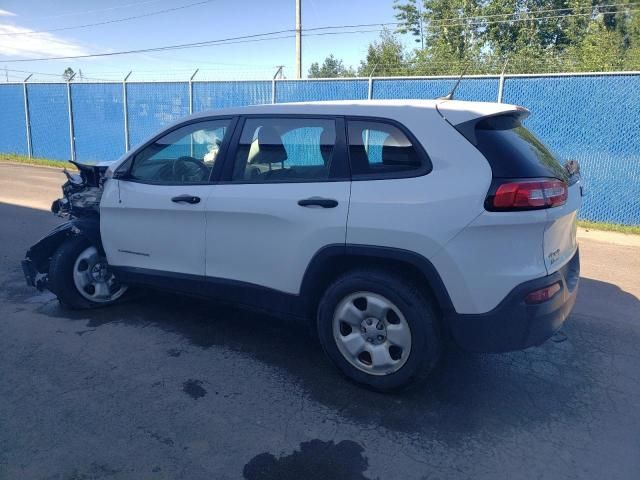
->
[348, 120, 423, 177]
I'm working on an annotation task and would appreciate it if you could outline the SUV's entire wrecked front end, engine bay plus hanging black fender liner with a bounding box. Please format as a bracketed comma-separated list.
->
[22, 162, 107, 291]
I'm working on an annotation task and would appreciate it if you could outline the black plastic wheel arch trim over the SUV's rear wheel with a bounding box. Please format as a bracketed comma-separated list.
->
[300, 244, 455, 319]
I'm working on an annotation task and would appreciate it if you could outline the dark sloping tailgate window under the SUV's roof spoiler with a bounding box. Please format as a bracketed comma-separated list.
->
[469, 115, 567, 180]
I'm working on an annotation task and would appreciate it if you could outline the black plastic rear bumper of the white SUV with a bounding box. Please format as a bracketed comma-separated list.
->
[449, 250, 580, 352]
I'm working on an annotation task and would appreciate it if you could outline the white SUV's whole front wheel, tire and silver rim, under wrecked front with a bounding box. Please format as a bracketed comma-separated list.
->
[49, 237, 127, 309]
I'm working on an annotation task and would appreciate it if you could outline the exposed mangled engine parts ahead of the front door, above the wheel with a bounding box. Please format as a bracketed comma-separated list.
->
[51, 162, 107, 218]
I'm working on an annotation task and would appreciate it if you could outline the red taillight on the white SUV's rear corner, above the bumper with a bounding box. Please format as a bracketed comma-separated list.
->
[490, 179, 569, 210]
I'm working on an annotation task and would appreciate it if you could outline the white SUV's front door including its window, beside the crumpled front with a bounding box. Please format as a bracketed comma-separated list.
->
[100, 118, 232, 276]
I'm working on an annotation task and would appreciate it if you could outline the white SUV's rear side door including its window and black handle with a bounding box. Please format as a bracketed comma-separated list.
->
[205, 116, 350, 294]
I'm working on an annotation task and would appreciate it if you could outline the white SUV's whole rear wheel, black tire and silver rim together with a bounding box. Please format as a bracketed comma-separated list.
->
[318, 270, 441, 390]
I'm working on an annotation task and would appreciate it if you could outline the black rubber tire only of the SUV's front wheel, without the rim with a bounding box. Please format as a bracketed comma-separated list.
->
[47, 236, 125, 310]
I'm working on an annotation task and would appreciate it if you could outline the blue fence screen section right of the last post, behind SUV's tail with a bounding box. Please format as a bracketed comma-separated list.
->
[504, 75, 640, 224]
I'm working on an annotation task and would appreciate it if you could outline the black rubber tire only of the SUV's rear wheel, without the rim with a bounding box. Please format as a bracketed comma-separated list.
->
[317, 269, 443, 391]
